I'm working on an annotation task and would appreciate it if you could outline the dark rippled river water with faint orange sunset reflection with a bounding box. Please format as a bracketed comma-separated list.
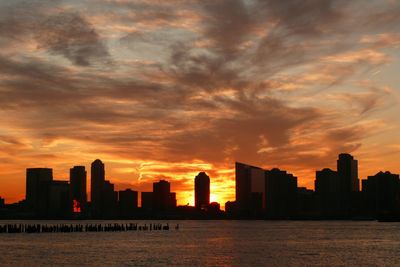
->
[0, 221, 400, 266]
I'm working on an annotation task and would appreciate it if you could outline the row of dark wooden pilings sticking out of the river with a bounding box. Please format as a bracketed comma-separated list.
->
[0, 223, 179, 234]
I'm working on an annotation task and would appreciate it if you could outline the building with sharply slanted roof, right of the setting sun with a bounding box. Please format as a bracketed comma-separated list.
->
[235, 162, 265, 215]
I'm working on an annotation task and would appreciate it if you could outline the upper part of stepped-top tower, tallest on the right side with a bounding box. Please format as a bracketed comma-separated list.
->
[337, 153, 360, 192]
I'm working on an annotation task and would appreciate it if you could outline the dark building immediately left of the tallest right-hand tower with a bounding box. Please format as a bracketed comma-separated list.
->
[315, 168, 348, 217]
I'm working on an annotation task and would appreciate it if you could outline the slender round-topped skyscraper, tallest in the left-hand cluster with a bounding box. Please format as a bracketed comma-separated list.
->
[90, 159, 105, 216]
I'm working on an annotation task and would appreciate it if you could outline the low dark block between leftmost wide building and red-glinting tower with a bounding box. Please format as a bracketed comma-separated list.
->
[47, 181, 72, 218]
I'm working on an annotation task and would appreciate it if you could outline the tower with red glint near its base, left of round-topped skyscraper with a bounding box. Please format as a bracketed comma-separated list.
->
[69, 166, 87, 213]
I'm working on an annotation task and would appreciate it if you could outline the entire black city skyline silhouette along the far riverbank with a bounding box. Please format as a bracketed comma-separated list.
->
[0, 153, 400, 221]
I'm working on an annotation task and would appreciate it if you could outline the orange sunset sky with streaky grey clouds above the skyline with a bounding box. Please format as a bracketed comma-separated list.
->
[0, 0, 400, 206]
